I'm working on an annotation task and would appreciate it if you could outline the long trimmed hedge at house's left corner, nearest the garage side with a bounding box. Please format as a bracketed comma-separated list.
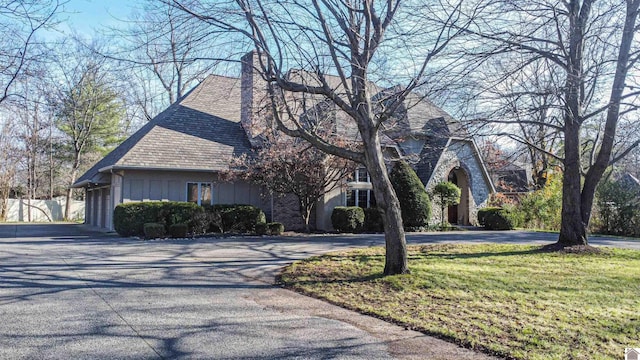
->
[113, 201, 204, 236]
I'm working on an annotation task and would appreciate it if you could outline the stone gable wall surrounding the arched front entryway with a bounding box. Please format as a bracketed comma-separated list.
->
[427, 140, 492, 225]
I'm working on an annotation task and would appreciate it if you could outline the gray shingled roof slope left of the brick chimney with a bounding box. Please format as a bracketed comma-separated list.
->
[75, 75, 251, 186]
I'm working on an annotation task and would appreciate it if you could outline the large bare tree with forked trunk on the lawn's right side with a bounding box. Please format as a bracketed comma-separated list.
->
[466, 0, 640, 247]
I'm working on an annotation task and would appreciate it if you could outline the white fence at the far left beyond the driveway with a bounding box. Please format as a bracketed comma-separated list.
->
[6, 196, 84, 222]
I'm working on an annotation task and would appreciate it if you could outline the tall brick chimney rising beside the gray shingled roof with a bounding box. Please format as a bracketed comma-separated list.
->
[240, 50, 268, 147]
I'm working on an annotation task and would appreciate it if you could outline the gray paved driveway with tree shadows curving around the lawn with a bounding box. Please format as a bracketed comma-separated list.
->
[0, 224, 640, 359]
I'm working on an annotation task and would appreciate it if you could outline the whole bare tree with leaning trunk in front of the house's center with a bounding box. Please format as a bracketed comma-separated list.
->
[173, 0, 476, 274]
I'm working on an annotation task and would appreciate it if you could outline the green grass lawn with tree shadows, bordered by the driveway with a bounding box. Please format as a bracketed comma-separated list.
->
[281, 245, 640, 359]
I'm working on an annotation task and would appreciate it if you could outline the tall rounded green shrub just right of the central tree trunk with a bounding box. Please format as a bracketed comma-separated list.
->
[389, 161, 431, 228]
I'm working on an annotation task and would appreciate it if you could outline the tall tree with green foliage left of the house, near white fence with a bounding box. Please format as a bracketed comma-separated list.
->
[52, 60, 124, 219]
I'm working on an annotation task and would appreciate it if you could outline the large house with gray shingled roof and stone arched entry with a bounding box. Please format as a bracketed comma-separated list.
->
[73, 52, 494, 230]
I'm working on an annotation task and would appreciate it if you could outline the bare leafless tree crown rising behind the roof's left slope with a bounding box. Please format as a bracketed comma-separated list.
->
[104, 0, 234, 120]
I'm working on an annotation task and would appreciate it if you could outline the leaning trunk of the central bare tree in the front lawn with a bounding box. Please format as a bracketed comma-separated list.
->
[362, 129, 409, 275]
